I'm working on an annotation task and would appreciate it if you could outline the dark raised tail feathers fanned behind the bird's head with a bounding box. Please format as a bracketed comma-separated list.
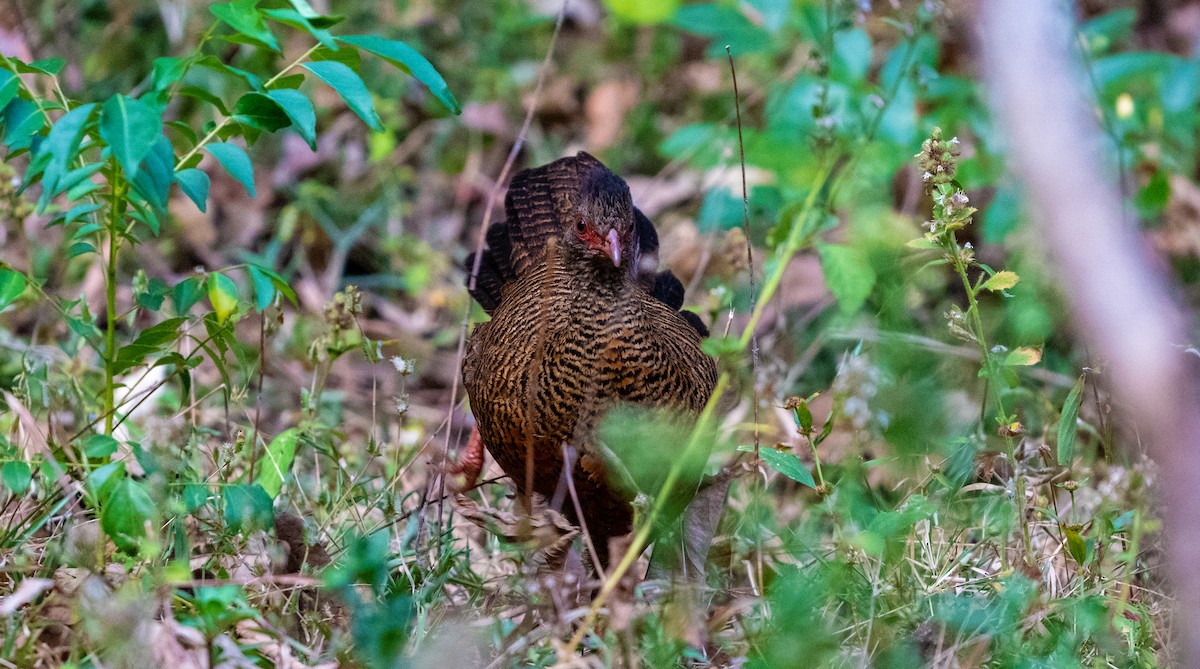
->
[466, 151, 708, 337]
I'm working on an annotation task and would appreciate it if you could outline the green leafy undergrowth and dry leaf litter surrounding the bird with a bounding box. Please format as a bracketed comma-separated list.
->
[0, 0, 1176, 668]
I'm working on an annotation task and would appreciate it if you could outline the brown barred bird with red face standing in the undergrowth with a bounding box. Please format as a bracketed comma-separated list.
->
[462, 151, 716, 565]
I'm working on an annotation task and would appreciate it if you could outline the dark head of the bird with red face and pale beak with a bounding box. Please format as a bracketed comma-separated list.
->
[566, 167, 637, 269]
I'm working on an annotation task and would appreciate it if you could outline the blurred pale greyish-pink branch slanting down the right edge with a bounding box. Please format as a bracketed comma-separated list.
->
[980, 0, 1200, 667]
